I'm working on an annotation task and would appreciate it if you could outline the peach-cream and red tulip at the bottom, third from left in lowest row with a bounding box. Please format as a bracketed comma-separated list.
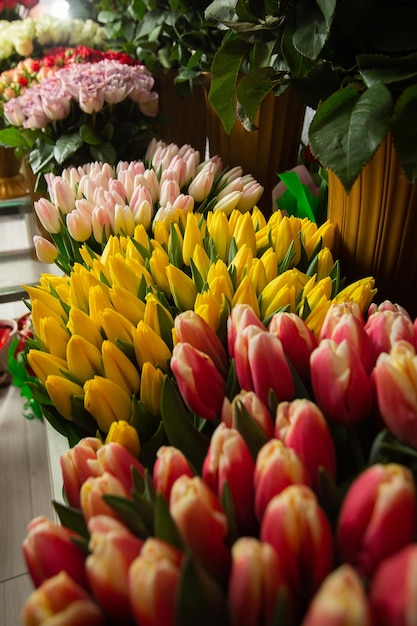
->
[128, 538, 183, 626]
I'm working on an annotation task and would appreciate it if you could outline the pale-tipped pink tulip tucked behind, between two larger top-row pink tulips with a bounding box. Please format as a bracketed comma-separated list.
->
[268, 313, 317, 381]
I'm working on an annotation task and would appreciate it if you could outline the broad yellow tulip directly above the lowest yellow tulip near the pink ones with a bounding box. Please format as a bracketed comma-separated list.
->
[84, 376, 132, 433]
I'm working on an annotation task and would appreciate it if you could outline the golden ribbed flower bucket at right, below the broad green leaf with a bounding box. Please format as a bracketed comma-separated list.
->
[328, 132, 417, 317]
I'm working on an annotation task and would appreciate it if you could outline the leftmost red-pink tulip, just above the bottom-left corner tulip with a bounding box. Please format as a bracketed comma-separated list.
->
[22, 516, 87, 587]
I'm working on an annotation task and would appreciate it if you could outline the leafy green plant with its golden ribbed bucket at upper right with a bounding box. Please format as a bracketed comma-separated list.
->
[208, 0, 417, 313]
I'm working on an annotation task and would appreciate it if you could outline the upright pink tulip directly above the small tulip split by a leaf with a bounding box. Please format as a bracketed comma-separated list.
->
[234, 325, 294, 405]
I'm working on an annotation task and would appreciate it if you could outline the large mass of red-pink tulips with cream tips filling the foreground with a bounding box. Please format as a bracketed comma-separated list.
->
[22, 294, 417, 626]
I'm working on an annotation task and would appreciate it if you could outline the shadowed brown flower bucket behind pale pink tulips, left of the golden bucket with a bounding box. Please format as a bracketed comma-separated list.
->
[206, 88, 305, 215]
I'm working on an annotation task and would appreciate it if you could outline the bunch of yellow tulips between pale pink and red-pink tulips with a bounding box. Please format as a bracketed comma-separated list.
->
[26, 201, 375, 445]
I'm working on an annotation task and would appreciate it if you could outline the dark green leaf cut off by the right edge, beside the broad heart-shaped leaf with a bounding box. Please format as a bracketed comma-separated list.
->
[392, 85, 417, 183]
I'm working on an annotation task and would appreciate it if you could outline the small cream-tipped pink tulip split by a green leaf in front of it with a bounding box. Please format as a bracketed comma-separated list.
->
[221, 390, 274, 439]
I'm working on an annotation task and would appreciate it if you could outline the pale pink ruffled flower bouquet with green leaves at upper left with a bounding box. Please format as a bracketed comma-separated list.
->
[0, 49, 158, 185]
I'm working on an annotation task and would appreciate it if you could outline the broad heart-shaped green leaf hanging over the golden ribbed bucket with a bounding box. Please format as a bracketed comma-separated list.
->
[309, 83, 392, 191]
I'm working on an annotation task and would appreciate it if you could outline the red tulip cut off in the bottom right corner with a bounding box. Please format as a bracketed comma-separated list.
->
[370, 543, 417, 626]
